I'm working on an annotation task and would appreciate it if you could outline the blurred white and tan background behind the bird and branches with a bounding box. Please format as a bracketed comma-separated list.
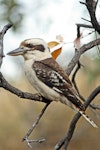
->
[0, 0, 100, 150]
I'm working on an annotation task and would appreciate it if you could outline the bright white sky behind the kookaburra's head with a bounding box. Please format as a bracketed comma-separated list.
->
[1, 0, 99, 80]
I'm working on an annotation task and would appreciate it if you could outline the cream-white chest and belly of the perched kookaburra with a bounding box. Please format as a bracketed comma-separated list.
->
[25, 61, 59, 101]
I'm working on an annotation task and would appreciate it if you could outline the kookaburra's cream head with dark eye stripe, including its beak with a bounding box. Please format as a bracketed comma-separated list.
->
[7, 38, 51, 60]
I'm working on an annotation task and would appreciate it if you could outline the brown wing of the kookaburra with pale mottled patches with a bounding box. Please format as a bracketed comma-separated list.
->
[32, 58, 84, 110]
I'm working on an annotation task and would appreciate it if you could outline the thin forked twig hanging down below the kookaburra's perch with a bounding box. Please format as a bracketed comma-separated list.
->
[22, 102, 50, 147]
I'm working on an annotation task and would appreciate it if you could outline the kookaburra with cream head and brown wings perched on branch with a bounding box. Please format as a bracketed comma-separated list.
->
[7, 38, 98, 128]
